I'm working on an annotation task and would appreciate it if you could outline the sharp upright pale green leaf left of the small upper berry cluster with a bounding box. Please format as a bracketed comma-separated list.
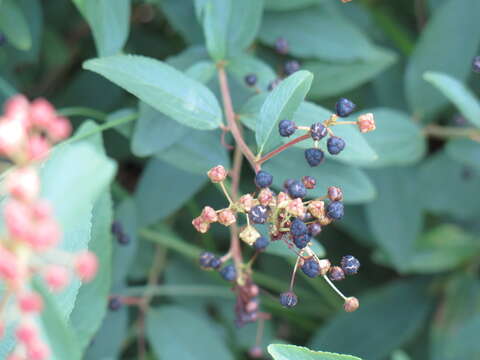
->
[255, 70, 313, 154]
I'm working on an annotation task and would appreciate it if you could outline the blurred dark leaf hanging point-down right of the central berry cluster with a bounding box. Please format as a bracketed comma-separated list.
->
[366, 168, 423, 271]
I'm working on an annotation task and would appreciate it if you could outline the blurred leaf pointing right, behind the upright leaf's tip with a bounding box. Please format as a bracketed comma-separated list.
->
[302, 50, 396, 98]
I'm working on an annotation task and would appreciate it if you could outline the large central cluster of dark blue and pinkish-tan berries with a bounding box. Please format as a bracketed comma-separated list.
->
[192, 166, 360, 324]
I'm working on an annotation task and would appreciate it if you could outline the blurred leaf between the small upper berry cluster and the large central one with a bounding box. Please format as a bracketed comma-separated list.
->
[264, 149, 376, 204]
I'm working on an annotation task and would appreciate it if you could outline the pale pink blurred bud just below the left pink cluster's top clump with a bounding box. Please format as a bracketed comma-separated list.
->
[6, 167, 40, 201]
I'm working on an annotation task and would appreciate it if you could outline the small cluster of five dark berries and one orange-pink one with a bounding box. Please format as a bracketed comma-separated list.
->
[278, 98, 375, 167]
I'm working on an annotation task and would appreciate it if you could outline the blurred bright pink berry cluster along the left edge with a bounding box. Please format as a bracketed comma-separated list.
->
[0, 95, 98, 360]
